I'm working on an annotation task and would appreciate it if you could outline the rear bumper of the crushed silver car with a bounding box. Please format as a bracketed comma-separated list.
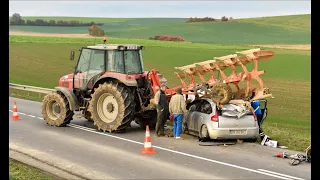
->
[208, 127, 259, 139]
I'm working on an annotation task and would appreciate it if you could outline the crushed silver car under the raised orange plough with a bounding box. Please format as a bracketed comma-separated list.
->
[183, 98, 267, 142]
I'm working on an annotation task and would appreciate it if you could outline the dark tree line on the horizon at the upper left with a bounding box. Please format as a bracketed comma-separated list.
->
[9, 13, 103, 26]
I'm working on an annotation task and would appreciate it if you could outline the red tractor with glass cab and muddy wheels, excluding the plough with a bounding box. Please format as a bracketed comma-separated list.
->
[42, 44, 166, 132]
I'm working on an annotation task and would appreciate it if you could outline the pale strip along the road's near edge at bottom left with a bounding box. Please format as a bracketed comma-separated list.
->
[9, 147, 88, 180]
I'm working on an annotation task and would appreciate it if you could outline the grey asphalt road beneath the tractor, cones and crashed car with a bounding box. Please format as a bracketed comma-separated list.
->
[9, 97, 311, 180]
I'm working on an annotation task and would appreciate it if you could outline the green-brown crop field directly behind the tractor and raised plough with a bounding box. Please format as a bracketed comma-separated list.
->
[9, 36, 311, 150]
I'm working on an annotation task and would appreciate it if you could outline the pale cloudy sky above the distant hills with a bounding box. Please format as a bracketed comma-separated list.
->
[9, 0, 311, 18]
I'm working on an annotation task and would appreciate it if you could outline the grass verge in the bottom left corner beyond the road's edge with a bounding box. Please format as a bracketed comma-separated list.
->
[9, 159, 62, 180]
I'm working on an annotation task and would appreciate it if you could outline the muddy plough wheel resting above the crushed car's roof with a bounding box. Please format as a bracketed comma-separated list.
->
[211, 82, 233, 104]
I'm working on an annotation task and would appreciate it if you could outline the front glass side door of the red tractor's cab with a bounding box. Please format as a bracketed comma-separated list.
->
[73, 48, 105, 90]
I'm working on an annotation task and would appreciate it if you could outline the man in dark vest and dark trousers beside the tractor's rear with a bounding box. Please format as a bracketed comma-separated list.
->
[154, 84, 168, 137]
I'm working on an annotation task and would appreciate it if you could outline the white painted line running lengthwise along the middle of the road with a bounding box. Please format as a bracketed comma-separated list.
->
[9, 110, 304, 180]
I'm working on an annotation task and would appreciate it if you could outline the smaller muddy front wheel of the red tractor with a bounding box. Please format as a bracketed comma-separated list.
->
[41, 92, 74, 127]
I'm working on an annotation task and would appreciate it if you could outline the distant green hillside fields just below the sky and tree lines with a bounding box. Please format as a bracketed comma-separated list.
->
[10, 14, 311, 44]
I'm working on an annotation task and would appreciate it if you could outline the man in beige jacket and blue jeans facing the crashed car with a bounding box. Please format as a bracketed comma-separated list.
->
[169, 88, 187, 139]
